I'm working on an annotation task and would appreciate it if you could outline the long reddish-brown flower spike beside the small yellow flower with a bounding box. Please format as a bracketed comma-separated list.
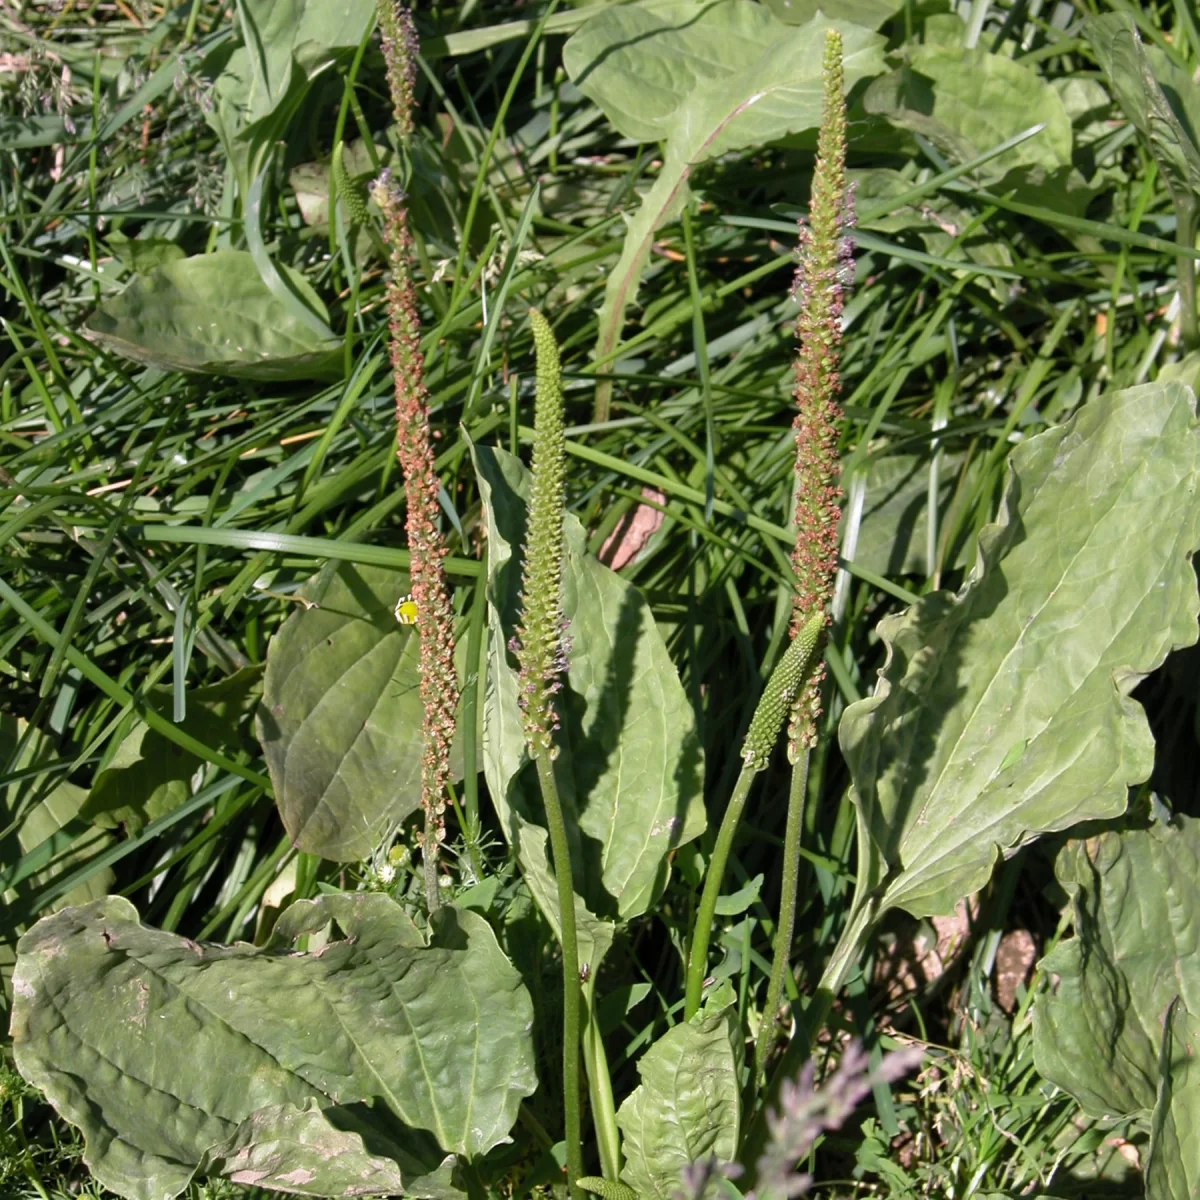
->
[372, 170, 458, 880]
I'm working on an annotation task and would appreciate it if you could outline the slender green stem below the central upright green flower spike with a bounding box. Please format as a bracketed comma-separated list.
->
[534, 750, 583, 1200]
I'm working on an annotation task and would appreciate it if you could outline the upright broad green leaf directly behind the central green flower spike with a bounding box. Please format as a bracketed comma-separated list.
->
[474, 446, 704, 919]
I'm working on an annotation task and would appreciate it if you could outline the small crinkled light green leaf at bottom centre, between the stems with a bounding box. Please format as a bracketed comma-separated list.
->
[617, 984, 743, 1200]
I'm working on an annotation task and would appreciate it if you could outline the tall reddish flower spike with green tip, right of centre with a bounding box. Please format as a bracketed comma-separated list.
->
[787, 30, 854, 762]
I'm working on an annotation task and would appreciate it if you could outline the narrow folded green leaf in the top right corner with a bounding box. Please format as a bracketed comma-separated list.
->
[1084, 12, 1200, 203]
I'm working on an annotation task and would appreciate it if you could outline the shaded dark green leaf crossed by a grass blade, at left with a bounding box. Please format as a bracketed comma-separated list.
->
[79, 667, 262, 835]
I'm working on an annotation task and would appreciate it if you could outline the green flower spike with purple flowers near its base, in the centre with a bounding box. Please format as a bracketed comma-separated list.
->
[509, 310, 571, 756]
